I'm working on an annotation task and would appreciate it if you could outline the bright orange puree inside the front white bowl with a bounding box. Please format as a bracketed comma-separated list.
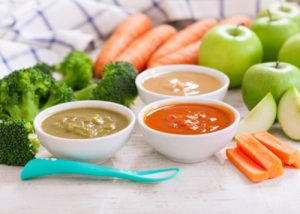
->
[144, 103, 234, 135]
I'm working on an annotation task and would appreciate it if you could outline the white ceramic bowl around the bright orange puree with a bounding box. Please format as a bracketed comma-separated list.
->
[138, 97, 240, 163]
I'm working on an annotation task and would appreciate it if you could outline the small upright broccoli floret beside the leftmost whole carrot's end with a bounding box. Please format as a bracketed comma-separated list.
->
[55, 51, 93, 90]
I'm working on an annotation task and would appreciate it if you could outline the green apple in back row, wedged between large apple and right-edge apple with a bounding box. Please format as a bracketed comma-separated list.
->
[251, 17, 299, 62]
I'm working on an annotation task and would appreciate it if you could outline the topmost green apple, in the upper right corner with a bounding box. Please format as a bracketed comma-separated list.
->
[258, 2, 300, 27]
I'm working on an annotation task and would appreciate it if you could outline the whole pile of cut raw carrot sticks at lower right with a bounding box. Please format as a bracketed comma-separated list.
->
[226, 131, 300, 182]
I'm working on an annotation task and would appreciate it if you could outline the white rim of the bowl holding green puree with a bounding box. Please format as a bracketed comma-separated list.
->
[33, 100, 136, 143]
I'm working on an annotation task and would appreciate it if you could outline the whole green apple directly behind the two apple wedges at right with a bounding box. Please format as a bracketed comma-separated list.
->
[242, 62, 300, 110]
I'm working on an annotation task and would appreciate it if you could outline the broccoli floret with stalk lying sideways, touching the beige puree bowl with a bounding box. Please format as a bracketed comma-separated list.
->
[75, 62, 137, 106]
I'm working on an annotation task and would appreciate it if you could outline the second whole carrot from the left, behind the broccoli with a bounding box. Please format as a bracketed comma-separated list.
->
[116, 25, 176, 72]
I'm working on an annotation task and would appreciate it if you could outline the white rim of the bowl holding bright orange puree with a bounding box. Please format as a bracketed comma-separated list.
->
[138, 97, 240, 138]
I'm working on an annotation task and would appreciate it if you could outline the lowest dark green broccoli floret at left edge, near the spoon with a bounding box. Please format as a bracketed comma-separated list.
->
[0, 119, 40, 166]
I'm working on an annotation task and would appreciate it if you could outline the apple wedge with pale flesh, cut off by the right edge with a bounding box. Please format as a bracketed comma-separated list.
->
[278, 87, 300, 140]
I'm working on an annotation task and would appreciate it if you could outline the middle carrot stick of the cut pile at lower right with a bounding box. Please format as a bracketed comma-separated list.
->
[235, 133, 283, 178]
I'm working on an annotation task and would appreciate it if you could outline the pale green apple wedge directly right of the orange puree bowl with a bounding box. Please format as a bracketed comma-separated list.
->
[237, 92, 277, 135]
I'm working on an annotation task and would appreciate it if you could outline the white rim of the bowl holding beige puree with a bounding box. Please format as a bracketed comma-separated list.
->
[135, 64, 229, 98]
